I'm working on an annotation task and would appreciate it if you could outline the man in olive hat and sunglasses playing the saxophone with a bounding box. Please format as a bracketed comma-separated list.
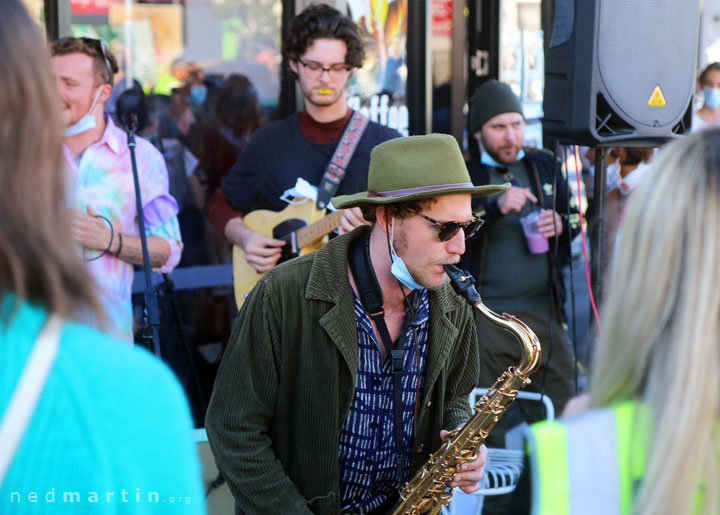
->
[206, 134, 509, 514]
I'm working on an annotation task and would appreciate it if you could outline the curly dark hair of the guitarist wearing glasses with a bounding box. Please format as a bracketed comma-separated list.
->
[283, 4, 365, 68]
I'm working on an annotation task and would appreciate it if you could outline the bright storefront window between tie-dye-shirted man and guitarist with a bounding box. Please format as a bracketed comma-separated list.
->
[70, 0, 282, 111]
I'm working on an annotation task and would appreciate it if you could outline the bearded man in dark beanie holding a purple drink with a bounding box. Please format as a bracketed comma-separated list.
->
[461, 80, 577, 514]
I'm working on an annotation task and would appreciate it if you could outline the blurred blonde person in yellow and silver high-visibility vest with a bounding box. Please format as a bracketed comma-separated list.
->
[509, 129, 720, 515]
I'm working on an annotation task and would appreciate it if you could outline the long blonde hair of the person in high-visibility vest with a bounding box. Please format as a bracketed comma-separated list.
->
[590, 130, 720, 515]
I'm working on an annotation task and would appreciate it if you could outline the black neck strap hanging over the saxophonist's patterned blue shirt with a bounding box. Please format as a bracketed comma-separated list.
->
[348, 232, 417, 486]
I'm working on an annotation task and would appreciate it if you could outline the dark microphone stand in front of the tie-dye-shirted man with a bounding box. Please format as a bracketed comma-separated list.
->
[123, 114, 162, 358]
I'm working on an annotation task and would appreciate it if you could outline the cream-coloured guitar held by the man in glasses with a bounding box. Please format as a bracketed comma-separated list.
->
[233, 199, 342, 309]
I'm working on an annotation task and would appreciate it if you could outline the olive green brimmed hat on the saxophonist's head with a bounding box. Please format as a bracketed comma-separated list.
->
[332, 134, 510, 209]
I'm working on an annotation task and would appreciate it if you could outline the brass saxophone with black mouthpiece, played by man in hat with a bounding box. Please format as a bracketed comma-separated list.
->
[390, 265, 540, 515]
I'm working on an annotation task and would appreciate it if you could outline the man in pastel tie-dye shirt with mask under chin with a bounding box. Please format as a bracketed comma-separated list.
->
[51, 38, 182, 342]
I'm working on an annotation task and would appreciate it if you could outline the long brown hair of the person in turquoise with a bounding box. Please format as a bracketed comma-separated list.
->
[0, 0, 98, 317]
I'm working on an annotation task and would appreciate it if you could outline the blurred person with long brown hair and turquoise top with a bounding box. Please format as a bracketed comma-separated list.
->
[0, 0, 204, 514]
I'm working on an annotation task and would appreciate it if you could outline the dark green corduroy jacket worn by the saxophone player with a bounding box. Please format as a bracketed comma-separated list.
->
[206, 227, 478, 515]
